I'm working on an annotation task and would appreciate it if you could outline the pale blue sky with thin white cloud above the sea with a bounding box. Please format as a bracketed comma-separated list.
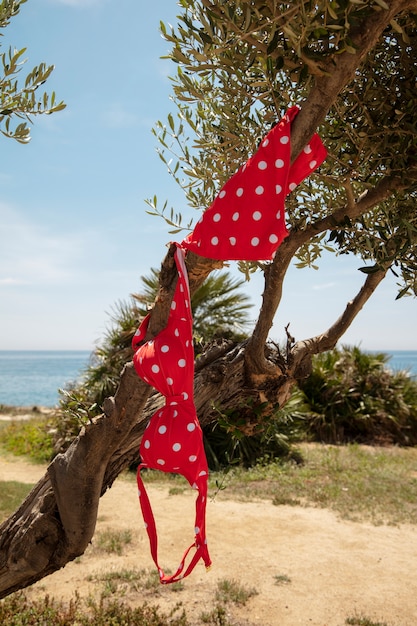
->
[0, 0, 417, 350]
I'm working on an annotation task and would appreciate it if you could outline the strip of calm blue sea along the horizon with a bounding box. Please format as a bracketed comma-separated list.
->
[0, 350, 417, 407]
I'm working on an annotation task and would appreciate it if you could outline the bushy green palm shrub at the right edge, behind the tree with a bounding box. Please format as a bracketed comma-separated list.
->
[299, 347, 417, 445]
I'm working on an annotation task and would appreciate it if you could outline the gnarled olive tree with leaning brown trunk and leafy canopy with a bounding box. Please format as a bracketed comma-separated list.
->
[0, 0, 417, 596]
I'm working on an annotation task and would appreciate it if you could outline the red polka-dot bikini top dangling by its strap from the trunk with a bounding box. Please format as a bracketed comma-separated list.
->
[132, 244, 211, 583]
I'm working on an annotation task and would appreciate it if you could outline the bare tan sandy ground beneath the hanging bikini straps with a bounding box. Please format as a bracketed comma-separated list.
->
[0, 448, 417, 626]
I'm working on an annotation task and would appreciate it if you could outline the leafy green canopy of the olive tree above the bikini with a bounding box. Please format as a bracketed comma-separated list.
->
[148, 0, 417, 296]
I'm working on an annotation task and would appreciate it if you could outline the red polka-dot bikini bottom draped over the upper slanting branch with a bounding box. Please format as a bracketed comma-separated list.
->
[182, 106, 327, 261]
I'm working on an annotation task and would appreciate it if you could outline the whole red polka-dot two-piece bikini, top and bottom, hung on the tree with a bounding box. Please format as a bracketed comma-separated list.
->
[132, 106, 326, 584]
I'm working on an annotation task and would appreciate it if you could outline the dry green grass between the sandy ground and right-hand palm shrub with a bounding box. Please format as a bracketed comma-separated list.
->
[211, 444, 417, 525]
